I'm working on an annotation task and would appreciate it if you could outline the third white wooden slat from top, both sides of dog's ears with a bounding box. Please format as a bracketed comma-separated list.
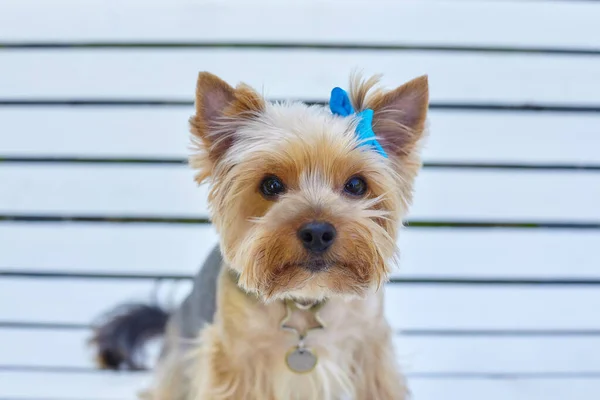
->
[0, 107, 600, 165]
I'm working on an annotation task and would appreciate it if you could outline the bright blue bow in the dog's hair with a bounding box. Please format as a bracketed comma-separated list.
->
[329, 87, 387, 158]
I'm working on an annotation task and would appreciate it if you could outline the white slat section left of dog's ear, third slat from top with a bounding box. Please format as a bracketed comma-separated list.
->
[0, 106, 194, 159]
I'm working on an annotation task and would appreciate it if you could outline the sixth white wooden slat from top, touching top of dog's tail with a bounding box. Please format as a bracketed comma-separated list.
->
[0, 278, 600, 330]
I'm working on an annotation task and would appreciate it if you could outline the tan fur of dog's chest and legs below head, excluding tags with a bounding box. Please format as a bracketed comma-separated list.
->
[149, 272, 406, 400]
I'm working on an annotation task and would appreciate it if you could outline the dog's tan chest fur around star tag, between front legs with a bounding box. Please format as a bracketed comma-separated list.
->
[204, 266, 381, 400]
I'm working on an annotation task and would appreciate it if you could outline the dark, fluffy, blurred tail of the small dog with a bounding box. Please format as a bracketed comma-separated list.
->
[91, 304, 169, 370]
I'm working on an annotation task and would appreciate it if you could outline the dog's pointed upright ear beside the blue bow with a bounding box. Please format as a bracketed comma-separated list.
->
[371, 75, 429, 157]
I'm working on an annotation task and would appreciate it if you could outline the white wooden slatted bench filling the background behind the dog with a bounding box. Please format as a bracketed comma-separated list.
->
[0, 0, 600, 400]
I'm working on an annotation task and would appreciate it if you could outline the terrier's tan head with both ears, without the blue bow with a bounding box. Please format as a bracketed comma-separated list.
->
[190, 73, 428, 300]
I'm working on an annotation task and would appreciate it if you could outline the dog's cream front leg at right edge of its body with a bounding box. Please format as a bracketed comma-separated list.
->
[356, 324, 408, 400]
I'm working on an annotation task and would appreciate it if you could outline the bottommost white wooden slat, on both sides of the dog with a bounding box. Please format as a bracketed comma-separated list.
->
[0, 371, 600, 400]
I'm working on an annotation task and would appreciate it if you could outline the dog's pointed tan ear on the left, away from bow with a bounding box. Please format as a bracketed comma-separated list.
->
[190, 72, 265, 182]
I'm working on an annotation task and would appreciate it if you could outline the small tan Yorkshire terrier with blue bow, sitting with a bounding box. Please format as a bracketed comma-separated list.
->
[93, 72, 429, 400]
